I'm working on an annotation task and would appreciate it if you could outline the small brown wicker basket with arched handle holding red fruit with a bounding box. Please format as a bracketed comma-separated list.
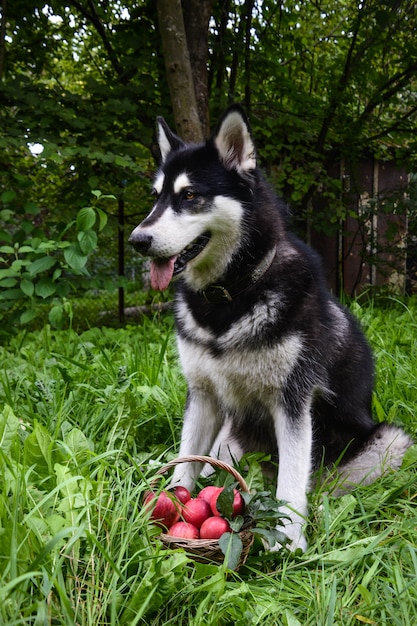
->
[150, 455, 253, 567]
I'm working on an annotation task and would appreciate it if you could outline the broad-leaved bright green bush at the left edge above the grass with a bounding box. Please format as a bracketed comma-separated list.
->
[0, 190, 114, 332]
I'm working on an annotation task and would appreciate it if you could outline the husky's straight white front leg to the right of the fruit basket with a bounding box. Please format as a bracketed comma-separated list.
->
[273, 404, 312, 551]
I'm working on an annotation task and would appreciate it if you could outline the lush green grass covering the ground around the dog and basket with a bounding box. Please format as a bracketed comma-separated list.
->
[0, 300, 417, 626]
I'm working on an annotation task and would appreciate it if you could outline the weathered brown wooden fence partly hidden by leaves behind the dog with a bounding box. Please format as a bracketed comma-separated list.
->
[310, 157, 408, 295]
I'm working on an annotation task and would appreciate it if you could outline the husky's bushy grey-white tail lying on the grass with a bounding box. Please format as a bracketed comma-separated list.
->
[336, 422, 413, 494]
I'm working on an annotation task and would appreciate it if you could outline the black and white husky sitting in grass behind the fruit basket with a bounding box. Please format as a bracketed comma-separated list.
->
[130, 105, 411, 549]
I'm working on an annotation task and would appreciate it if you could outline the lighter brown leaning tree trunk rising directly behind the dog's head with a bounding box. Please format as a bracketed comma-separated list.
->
[156, 0, 203, 142]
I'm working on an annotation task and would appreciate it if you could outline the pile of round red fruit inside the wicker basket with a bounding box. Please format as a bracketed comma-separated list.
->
[144, 486, 245, 539]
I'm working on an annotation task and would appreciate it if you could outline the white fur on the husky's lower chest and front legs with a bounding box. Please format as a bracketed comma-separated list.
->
[169, 320, 312, 549]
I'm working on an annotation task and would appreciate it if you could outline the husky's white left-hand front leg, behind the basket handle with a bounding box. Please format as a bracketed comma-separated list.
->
[172, 388, 223, 491]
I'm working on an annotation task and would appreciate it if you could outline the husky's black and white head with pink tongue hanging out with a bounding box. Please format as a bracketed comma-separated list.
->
[129, 105, 256, 290]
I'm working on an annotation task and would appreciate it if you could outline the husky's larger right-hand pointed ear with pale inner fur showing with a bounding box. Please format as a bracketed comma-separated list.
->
[214, 104, 256, 172]
